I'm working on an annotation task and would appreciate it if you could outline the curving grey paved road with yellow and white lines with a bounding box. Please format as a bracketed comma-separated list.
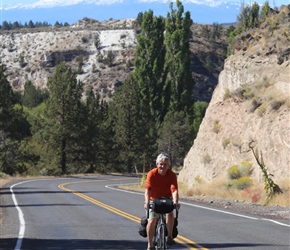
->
[0, 176, 290, 250]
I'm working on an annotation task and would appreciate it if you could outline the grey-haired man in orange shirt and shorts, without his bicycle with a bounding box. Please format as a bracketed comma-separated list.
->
[144, 153, 180, 250]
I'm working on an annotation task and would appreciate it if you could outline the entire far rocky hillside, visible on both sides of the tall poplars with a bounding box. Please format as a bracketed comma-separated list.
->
[0, 18, 227, 101]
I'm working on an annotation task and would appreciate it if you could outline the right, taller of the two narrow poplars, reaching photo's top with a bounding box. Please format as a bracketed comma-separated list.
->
[164, 0, 194, 114]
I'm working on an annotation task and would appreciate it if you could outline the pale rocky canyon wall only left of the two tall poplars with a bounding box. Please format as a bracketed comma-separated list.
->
[0, 18, 136, 98]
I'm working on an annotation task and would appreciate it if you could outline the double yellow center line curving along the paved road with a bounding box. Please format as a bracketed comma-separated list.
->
[58, 179, 207, 250]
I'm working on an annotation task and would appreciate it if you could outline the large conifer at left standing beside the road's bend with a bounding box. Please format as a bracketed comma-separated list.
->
[43, 62, 84, 174]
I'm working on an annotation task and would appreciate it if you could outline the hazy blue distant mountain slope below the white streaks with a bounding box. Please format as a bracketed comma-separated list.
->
[1, 2, 239, 25]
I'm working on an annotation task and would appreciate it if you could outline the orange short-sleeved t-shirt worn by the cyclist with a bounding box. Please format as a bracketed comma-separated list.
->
[145, 168, 178, 200]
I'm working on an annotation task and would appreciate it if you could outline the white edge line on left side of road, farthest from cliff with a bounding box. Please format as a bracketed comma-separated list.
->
[10, 178, 67, 250]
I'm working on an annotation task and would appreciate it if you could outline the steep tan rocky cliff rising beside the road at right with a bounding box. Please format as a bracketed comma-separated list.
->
[179, 5, 290, 186]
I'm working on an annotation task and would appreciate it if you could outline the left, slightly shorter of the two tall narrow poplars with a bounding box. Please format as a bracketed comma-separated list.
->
[134, 10, 165, 124]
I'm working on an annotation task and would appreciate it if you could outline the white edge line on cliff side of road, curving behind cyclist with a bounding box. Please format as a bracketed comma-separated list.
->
[105, 183, 290, 227]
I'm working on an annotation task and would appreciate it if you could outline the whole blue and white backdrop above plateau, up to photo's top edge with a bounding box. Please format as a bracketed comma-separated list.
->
[0, 0, 290, 25]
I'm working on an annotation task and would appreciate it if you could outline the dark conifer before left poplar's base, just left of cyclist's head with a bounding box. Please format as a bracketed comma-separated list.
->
[110, 75, 156, 172]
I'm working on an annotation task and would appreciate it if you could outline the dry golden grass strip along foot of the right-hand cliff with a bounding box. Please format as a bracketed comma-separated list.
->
[121, 178, 290, 207]
